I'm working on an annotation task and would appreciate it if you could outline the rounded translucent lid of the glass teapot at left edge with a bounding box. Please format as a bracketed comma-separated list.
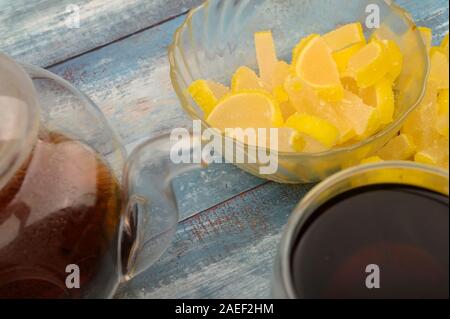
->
[0, 53, 39, 189]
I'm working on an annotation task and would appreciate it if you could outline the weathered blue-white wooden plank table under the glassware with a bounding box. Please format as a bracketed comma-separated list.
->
[0, 0, 449, 298]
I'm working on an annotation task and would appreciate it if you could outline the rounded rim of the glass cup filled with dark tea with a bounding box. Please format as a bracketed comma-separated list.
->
[277, 161, 449, 298]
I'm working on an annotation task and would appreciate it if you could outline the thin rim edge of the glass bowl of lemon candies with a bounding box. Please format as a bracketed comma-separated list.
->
[168, 0, 430, 159]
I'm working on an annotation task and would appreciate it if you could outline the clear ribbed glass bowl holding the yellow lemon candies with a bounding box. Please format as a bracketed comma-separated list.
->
[169, 0, 428, 183]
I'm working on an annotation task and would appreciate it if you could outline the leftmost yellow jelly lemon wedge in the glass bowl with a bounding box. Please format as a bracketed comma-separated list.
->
[188, 80, 229, 117]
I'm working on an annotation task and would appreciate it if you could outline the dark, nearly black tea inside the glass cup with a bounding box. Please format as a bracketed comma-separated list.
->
[290, 184, 449, 299]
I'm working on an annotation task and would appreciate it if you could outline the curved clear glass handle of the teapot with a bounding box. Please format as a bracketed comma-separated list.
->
[119, 132, 201, 280]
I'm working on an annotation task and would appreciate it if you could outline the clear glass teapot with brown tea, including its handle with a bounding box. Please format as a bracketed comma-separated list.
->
[0, 54, 198, 299]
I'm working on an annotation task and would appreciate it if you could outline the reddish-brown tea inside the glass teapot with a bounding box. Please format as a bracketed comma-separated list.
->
[0, 132, 121, 299]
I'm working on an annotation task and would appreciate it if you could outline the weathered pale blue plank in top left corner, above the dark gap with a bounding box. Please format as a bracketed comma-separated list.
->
[0, 0, 202, 67]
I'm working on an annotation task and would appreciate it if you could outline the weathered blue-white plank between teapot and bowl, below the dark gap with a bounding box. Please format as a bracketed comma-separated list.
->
[50, 17, 192, 148]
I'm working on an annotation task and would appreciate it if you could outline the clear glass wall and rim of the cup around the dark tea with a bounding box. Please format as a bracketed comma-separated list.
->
[272, 162, 449, 299]
